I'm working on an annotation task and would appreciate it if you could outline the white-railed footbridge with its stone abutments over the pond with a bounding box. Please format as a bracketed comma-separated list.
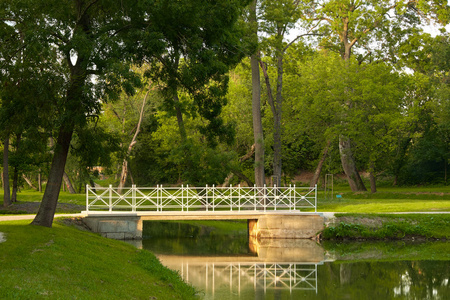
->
[83, 185, 323, 239]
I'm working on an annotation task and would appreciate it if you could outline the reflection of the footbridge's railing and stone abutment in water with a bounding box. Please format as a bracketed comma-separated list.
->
[152, 239, 325, 299]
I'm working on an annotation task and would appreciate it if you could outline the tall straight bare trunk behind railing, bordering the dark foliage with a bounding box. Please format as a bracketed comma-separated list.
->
[250, 0, 266, 187]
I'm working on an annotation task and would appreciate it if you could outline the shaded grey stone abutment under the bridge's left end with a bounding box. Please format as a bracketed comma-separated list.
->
[83, 215, 142, 240]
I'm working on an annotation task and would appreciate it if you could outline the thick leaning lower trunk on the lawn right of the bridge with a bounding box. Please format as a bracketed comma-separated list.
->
[339, 136, 367, 192]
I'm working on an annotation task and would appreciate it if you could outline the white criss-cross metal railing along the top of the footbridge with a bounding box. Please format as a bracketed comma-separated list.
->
[86, 185, 317, 212]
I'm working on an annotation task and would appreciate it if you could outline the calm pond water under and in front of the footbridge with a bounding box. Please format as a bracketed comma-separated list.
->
[137, 222, 450, 299]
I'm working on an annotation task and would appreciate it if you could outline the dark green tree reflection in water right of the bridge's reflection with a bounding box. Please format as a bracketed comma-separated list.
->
[318, 261, 450, 299]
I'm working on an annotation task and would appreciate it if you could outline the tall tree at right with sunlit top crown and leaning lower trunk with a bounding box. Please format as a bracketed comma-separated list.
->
[313, 0, 449, 191]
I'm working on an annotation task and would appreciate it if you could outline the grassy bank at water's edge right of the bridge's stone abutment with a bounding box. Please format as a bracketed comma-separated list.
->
[322, 214, 450, 240]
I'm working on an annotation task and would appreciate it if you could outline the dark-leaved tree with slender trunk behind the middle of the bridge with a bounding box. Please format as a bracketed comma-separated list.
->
[142, 0, 250, 184]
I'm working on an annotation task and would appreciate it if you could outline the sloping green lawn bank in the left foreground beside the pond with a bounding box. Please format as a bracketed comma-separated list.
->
[0, 221, 195, 299]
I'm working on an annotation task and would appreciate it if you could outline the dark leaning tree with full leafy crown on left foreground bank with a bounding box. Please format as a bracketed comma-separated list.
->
[2, 0, 158, 227]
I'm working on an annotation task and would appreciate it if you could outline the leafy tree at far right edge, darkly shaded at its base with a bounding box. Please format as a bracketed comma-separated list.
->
[395, 34, 450, 183]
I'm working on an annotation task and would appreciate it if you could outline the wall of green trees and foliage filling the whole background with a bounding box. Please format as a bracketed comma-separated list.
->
[0, 0, 450, 217]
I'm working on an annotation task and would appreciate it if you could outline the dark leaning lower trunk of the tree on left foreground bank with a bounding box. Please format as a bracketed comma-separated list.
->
[31, 124, 74, 227]
